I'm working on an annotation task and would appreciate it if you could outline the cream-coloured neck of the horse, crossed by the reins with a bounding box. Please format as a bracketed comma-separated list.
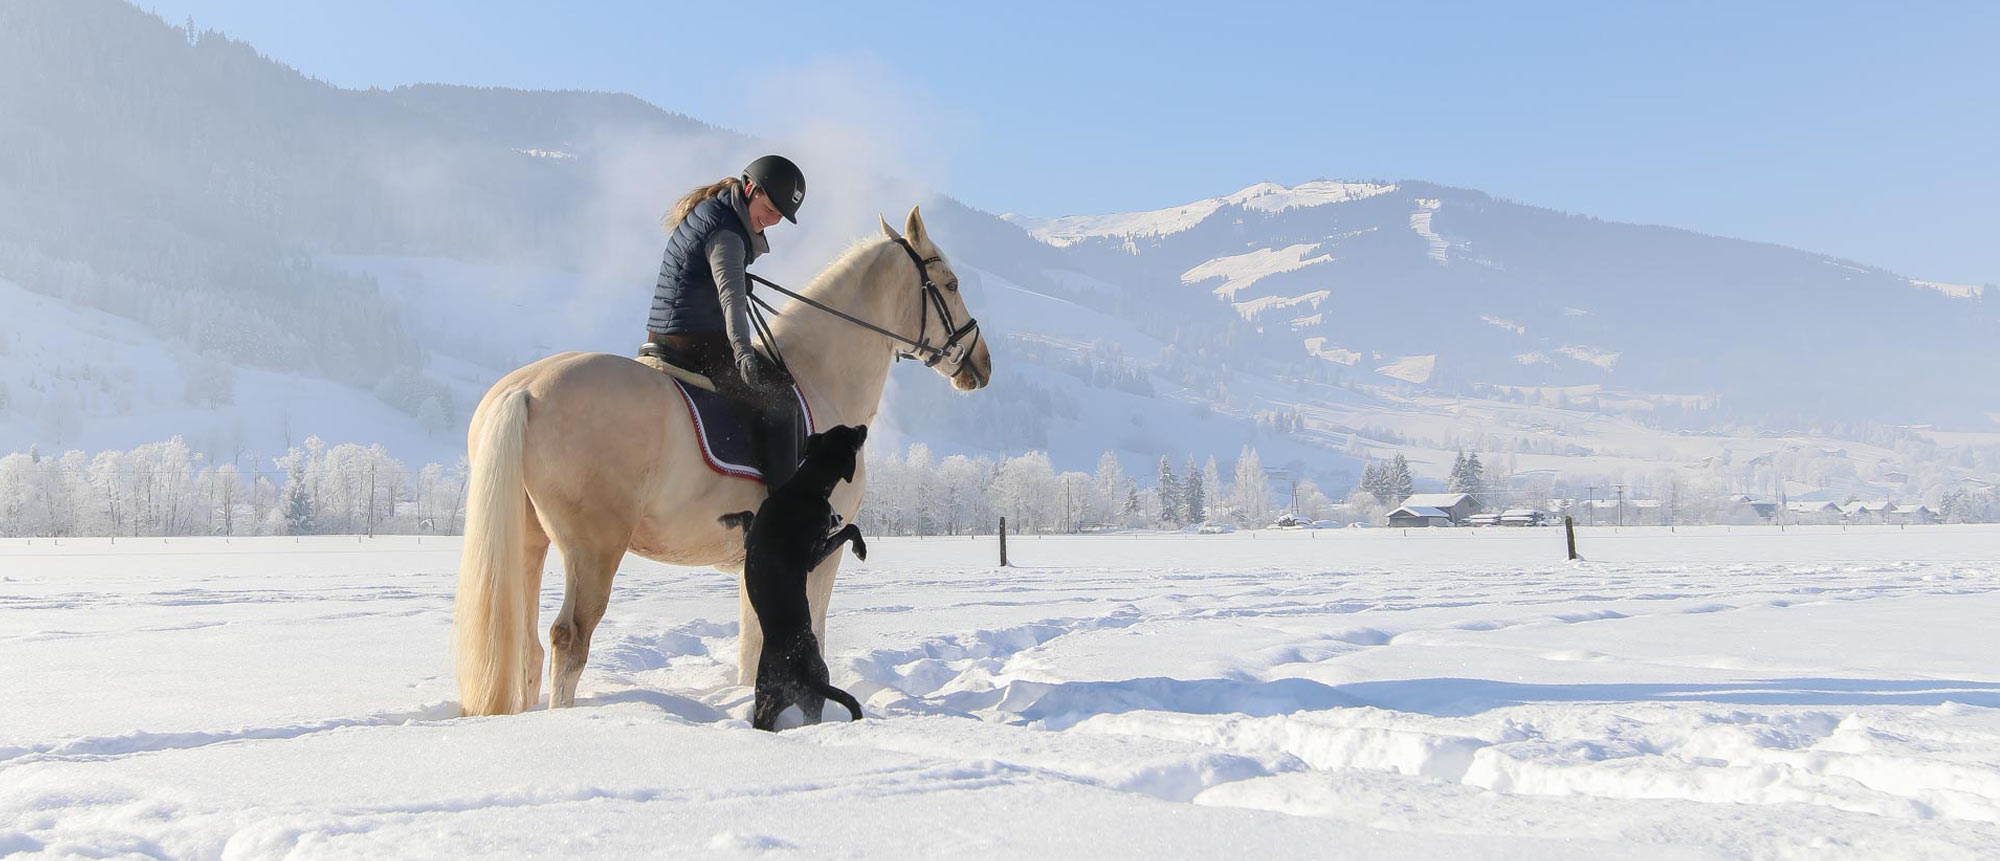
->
[772, 242, 908, 428]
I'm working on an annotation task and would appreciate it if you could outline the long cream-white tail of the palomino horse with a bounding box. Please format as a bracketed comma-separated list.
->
[452, 390, 530, 715]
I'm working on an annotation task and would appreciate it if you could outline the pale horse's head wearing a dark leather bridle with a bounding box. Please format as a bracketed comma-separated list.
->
[882, 206, 994, 392]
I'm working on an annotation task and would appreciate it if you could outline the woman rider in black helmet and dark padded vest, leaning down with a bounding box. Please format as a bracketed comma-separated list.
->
[640, 156, 806, 487]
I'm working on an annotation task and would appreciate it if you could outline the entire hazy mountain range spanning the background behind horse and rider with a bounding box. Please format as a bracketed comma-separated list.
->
[0, 0, 2000, 499]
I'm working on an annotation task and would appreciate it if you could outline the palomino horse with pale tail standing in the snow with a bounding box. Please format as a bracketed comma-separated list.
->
[454, 208, 992, 715]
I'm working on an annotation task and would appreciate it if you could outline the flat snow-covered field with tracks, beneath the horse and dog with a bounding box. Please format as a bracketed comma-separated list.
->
[0, 527, 2000, 859]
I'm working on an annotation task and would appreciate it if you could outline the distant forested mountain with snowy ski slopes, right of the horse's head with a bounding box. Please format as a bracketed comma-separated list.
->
[1006, 182, 2000, 424]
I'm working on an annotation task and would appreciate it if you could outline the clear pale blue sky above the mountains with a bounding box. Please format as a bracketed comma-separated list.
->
[140, 0, 2000, 282]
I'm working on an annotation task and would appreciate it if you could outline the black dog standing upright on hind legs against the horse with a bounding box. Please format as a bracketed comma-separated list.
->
[718, 424, 868, 731]
